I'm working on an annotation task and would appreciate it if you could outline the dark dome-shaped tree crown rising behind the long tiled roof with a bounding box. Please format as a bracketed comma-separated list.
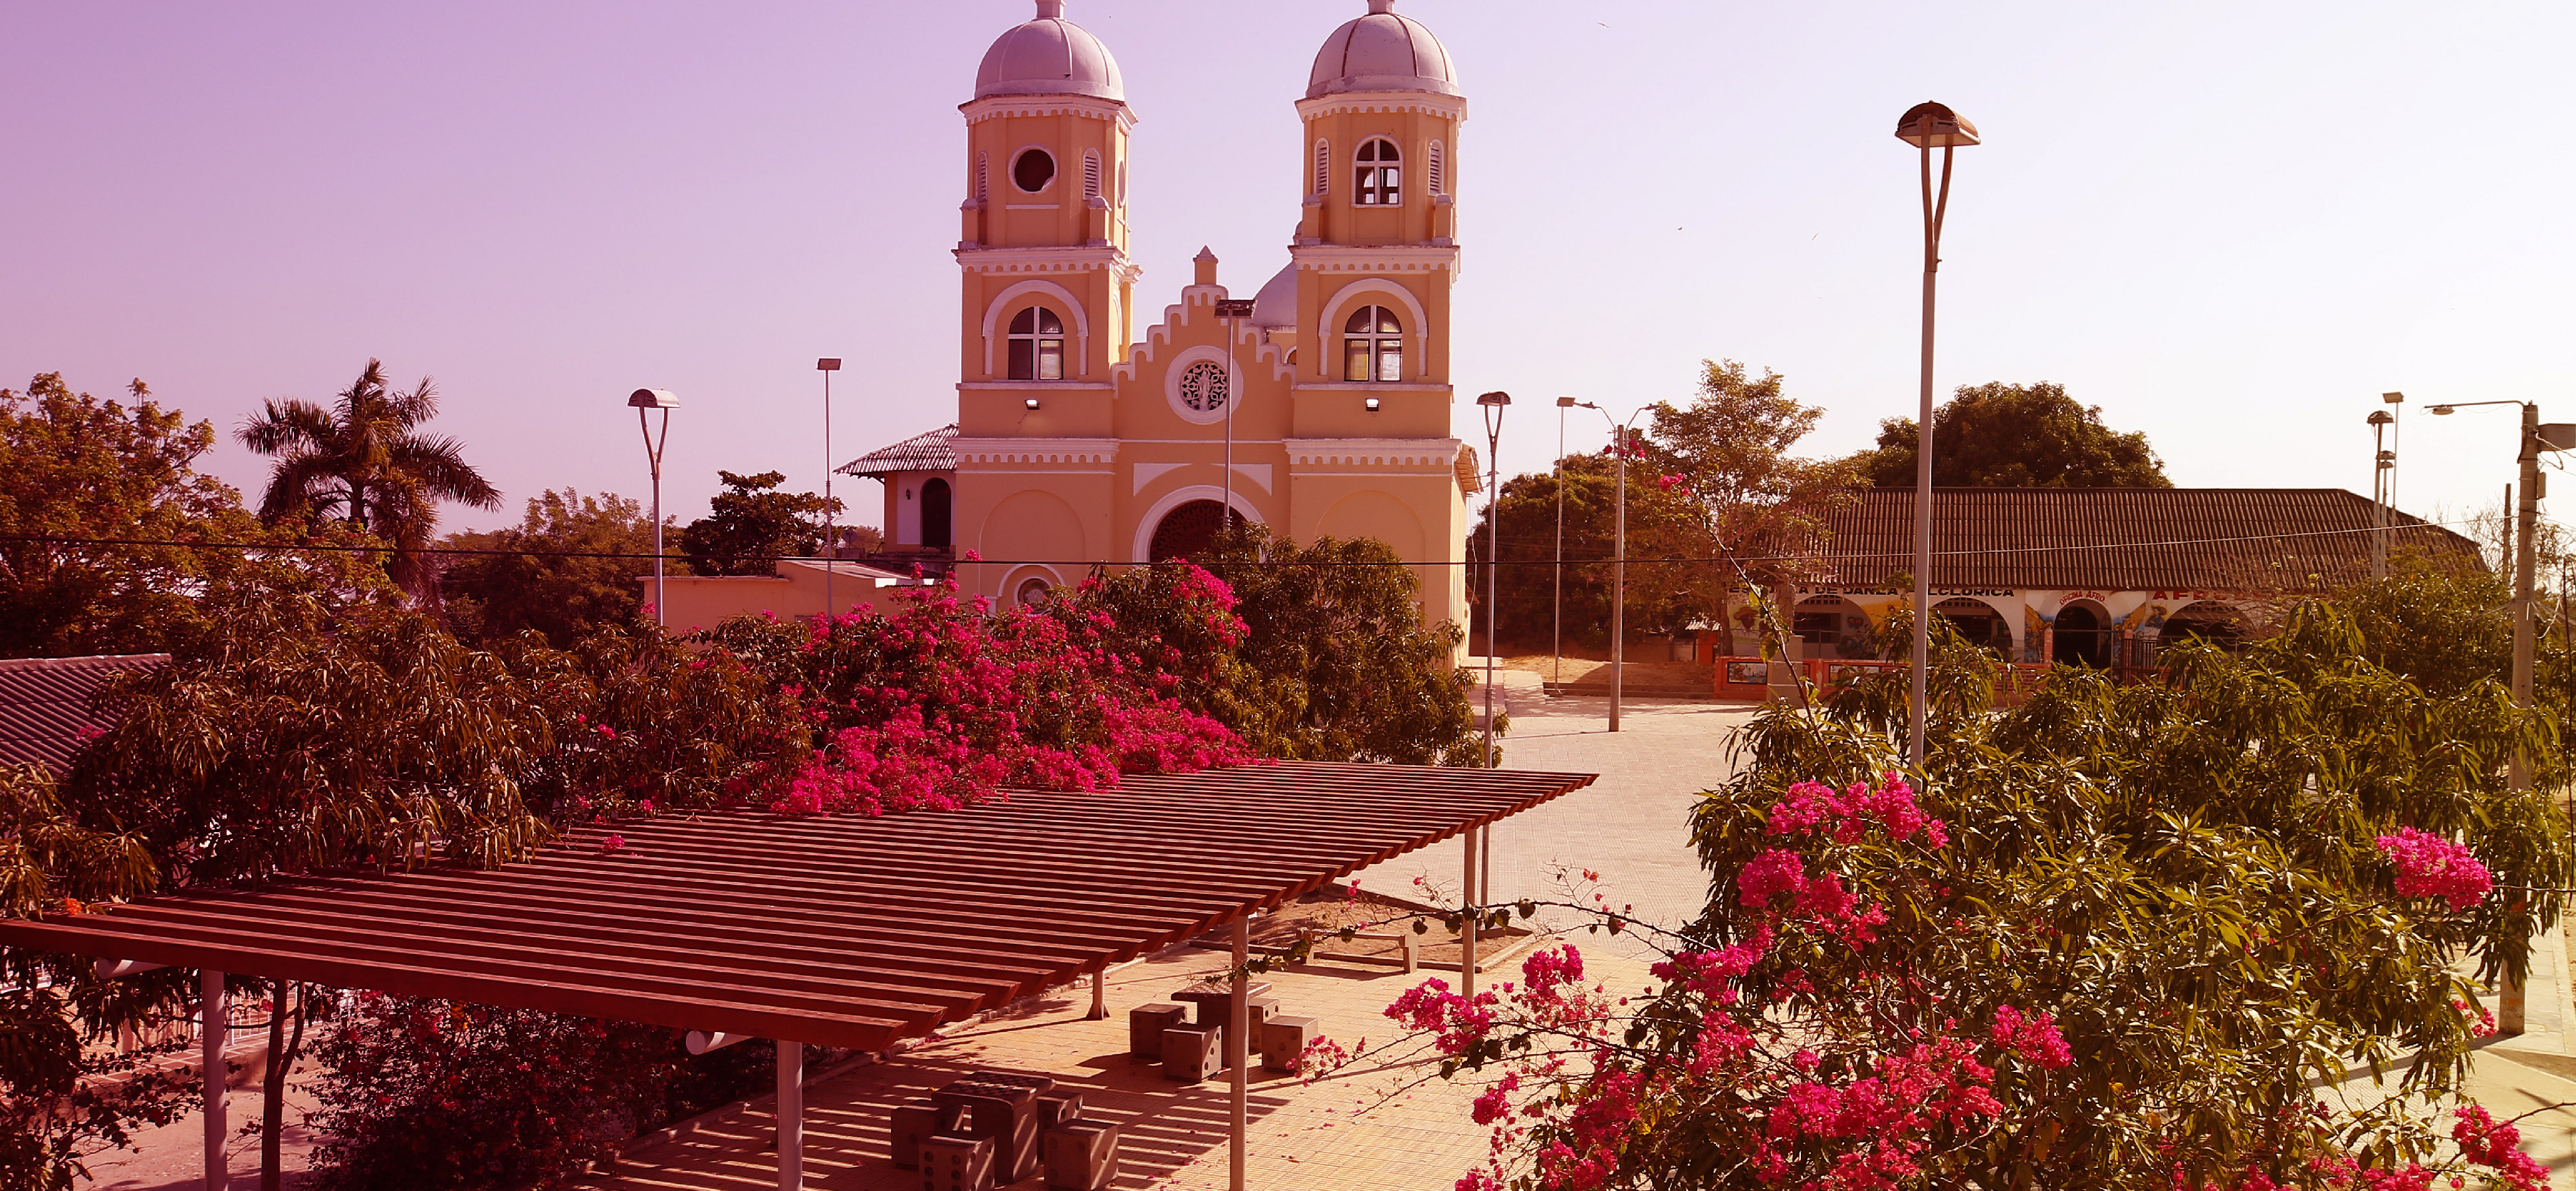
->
[1852, 381, 2174, 487]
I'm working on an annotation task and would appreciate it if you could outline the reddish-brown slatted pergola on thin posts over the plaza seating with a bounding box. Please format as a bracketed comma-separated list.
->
[0, 763, 1592, 1191]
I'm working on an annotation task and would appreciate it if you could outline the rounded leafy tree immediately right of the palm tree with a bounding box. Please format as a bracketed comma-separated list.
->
[438, 487, 685, 647]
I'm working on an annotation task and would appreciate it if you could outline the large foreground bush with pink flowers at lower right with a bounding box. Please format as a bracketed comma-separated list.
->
[1329, 606, 2568, 1191]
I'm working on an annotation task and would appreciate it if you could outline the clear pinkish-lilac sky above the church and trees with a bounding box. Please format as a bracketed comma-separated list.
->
[0, 0, 2576, 538]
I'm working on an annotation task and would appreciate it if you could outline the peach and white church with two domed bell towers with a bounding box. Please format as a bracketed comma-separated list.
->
[840, 0, 1476, 624]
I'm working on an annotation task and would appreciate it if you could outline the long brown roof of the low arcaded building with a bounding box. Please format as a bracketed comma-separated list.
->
[1821, 487, 2478, 590]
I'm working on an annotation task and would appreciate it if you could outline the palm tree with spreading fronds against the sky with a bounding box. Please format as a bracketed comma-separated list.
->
[237, 361, 500, 598]
